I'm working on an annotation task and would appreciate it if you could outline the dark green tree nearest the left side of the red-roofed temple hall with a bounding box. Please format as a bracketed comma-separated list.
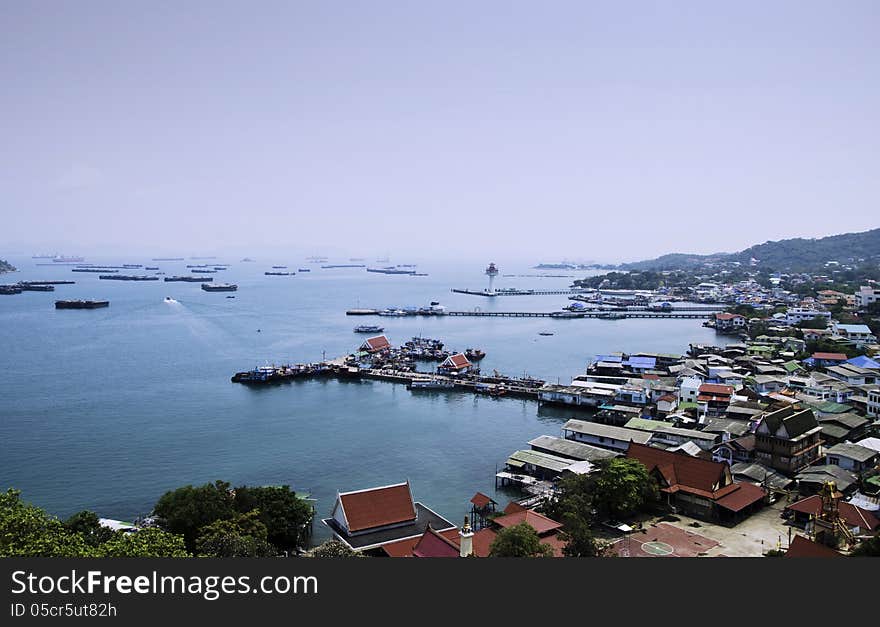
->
[233, 485, 314, 550]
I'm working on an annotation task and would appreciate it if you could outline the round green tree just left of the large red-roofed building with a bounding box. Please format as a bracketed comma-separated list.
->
[593, 457, 659, 518]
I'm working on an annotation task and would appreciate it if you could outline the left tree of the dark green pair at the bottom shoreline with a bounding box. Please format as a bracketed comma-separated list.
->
[153, 481, 235, 551]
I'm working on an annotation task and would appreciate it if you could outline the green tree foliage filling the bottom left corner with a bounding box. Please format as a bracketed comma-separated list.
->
[0, 488, 90, 557]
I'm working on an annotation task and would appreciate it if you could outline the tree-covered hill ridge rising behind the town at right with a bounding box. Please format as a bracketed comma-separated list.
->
[619, 228, 880, 272]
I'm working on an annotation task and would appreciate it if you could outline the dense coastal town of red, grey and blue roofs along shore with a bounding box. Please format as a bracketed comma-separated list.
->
[322, 276, 880, 557]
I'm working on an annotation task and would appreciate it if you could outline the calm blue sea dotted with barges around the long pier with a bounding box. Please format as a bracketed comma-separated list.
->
[0, 258, 721, 540]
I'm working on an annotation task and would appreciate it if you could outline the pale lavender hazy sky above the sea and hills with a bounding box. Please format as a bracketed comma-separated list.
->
[0, 0, 880, 261]
